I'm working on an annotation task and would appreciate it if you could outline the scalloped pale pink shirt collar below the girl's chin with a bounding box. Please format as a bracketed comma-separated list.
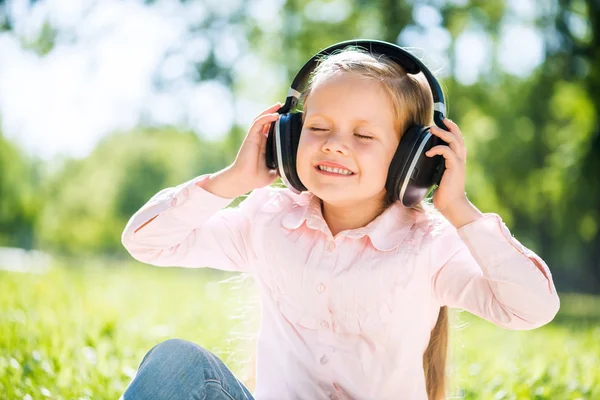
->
[281, 192, 415, 251]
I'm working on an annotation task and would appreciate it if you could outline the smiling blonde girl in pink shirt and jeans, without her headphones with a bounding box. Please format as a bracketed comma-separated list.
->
[122, 50, 559, 400]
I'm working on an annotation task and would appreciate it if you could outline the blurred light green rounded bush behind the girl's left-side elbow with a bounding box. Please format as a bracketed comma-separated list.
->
[37, 129, 226, 254]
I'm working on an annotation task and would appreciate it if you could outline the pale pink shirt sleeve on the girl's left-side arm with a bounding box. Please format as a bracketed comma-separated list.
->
[121, 175, 266, 272]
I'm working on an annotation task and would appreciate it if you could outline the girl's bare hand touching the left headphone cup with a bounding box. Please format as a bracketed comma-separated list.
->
[230, 103, 281, 192]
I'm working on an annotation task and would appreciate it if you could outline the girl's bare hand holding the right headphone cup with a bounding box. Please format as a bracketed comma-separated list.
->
[425, 118, 470, 216]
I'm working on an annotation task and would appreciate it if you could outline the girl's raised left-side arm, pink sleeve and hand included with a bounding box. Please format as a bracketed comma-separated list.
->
[122, 103, 281, 271]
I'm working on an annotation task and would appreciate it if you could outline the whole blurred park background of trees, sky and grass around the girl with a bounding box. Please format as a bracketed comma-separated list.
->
[0, 0, 600, 399]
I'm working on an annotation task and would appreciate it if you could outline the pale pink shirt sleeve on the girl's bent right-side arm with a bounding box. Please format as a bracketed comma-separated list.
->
[431, 213, 560, 330]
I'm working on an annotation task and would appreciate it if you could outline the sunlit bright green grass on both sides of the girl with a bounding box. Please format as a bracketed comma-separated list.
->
[0, 262, 600, 400]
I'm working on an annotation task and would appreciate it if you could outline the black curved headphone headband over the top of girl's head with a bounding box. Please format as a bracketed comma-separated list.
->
[280, 39, 446, 129]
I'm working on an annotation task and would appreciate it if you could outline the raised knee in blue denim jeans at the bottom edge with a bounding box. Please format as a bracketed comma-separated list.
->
[121, 339, 254, 400]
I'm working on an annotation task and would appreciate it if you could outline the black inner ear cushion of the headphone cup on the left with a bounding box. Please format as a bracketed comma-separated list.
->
[278, 112, 307, 193]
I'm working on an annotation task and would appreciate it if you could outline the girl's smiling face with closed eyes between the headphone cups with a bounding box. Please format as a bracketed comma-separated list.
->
[296, 72, 400, 205]
